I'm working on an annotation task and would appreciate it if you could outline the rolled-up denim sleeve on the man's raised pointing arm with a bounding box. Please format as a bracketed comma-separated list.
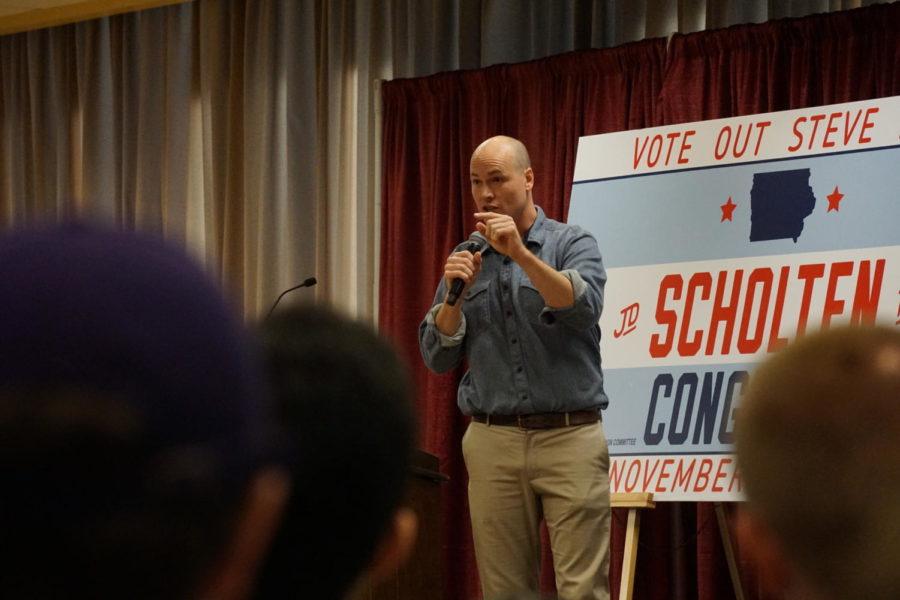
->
[540, 228, 606, 329]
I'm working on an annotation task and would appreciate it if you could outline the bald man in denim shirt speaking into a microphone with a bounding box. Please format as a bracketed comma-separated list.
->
[419, 136, 610, 600]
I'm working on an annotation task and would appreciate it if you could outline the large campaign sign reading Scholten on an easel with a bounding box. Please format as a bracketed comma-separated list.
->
[569, 97, 900, 500]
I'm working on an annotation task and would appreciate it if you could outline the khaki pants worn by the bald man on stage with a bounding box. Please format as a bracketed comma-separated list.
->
[462, 422, 610, 600]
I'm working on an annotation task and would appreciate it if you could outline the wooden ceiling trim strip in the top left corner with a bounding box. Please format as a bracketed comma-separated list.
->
[0, 0, 187, 35]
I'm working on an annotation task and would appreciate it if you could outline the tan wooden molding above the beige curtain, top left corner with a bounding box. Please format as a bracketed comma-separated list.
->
[0, 0, 193, 35]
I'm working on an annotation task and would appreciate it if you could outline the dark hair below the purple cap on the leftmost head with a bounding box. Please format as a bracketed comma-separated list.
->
[0, 387, 241, 598]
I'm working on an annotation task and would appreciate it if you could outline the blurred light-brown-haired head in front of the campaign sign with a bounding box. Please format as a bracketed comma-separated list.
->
[735, 327, 900, 600]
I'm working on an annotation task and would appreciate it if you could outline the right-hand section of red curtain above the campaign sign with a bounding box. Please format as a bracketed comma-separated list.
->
[659, 4, 900, 124]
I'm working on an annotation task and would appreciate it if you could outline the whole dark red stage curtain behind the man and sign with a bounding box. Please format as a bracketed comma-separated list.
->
[379, 4, 900, 600]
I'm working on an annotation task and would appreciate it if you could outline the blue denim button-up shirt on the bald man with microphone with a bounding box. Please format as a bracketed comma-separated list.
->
[419, 207, 609, 415]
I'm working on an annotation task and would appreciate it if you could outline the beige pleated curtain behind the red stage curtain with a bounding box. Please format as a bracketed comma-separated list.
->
[0, 0, 869, 320]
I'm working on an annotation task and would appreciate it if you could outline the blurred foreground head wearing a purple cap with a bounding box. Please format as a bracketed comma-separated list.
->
[0, 225, 287, 598]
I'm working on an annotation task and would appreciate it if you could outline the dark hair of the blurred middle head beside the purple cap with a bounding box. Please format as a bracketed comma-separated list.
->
[257, 307, 415, 599]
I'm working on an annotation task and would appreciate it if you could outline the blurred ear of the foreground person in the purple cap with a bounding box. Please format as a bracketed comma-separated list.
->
[198, 467, 291, 600]
